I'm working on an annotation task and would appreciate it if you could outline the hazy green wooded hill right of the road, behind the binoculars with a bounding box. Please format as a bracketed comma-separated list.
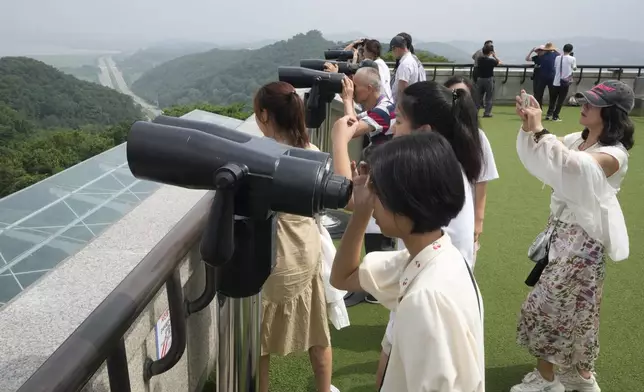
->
[132, 30, 336, 107]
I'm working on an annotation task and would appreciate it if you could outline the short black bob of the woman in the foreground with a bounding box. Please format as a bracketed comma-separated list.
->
[368, 132, 465, 234]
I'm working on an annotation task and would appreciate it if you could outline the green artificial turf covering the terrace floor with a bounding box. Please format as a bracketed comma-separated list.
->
[213, 107, 644, 392]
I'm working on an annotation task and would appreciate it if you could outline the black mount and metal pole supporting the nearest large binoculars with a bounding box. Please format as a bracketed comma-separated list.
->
[200, 164, 275, 392]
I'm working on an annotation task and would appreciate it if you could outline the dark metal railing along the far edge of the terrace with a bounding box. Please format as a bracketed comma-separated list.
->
[387, 62, 644, 84]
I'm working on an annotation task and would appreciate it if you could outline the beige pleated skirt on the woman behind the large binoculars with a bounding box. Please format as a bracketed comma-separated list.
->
[261, 214, 331, 355]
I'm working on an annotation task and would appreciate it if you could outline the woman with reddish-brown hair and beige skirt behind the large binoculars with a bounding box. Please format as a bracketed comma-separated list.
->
[254, 82, 336, 392]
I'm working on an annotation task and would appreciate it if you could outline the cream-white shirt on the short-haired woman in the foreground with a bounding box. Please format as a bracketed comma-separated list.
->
[359, 234, 485, 392]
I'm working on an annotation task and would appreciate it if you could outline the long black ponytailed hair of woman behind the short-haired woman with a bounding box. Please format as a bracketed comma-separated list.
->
[398, 81, 483, 184]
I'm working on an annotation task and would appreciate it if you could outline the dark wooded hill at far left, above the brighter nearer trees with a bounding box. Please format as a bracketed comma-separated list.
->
[0, 57, 141, 128]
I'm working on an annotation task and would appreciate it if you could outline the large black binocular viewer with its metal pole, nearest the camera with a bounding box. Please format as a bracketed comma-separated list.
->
[127, 116, 352, 392]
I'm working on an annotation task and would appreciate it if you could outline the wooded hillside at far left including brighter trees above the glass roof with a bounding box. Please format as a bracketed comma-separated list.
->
[0, 57, 141, 198]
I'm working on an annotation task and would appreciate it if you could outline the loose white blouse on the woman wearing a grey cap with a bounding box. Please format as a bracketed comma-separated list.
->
[517, 130, 629, 261]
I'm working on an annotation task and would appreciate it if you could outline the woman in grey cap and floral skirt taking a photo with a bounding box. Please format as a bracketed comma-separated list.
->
[511, 80, 635, 392]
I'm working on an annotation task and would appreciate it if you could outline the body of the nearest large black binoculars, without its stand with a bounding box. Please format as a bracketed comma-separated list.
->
[127, 115, 353, 217]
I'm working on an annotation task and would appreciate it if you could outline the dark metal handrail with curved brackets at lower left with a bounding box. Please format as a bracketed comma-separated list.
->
[18, 192, 216, 392]
